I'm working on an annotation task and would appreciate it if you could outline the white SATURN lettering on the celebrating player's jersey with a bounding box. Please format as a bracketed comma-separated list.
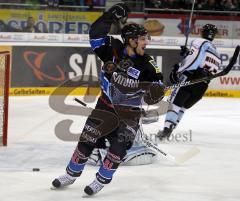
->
[112, 72, 139, 88]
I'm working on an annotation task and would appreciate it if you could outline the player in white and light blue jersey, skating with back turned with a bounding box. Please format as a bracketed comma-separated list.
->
[157, 24, 221, 140]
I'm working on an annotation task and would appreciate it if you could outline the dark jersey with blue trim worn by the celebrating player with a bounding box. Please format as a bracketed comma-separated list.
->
[89, 13, 162, 106]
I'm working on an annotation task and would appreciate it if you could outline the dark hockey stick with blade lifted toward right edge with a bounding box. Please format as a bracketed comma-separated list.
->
[165, 45, 240, 90]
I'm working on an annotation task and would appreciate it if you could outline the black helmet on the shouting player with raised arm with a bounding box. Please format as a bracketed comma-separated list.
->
[121, 23, 148, 43]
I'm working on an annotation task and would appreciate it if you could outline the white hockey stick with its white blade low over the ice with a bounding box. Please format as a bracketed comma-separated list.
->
[140, 126, 200, 165]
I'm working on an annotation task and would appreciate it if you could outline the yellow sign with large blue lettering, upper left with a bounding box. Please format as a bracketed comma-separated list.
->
[0, 9, 102, 34]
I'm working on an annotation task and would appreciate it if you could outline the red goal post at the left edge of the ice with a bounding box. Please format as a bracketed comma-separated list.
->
[0, 51, 10, 146]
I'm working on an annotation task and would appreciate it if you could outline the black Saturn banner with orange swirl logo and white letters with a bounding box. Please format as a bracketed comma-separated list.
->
[11, 46, 180, 87]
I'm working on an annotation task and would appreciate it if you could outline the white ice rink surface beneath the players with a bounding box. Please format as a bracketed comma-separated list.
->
[0, 97, 240, 201]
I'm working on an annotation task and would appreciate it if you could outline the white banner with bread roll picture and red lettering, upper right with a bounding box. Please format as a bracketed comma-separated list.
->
[129, 15, 240, 39]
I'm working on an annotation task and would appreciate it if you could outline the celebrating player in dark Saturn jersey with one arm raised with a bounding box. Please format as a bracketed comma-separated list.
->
[52, 3, 164, 195]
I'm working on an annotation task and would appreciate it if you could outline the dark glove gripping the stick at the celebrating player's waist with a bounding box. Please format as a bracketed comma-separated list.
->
[143, 82, 165, 105]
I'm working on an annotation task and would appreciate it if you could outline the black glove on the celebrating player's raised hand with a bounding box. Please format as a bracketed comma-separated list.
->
[108, 3, 130, 22]
